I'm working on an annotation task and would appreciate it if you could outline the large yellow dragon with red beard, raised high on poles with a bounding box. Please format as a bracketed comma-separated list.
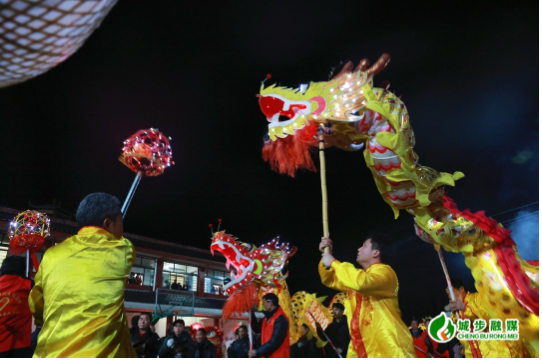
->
[258, 54, 539, 357]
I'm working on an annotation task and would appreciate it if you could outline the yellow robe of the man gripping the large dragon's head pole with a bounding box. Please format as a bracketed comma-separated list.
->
[318, 261, 416, 358]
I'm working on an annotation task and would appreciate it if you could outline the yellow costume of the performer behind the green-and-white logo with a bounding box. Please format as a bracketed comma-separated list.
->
[459, 293, 524, 358]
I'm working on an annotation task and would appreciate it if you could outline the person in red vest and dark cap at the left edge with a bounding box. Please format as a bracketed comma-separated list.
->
[0, 256, 33, 358]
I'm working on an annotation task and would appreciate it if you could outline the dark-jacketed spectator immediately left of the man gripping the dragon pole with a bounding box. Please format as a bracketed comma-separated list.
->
[318, 303, 350, 358]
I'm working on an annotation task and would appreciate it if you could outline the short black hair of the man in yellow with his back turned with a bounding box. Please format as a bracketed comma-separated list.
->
[75, 193, 121, 227]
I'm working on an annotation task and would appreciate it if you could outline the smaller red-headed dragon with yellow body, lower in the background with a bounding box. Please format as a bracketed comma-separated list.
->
[211, 232, 332, 347]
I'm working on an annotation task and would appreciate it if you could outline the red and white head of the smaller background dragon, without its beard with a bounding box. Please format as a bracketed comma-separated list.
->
[211, 232, 297, 296]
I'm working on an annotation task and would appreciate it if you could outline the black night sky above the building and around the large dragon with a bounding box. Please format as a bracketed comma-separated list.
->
[0, 0, 539, 319]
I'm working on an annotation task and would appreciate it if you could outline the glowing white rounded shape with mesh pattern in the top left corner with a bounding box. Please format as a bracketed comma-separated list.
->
[0, 0, 117, 88]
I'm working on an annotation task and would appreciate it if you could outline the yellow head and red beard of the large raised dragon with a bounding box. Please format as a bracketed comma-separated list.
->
[258, 54, 390, 176]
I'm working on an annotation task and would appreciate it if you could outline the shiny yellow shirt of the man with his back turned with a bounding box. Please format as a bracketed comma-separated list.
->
[29, 227, 137, 358]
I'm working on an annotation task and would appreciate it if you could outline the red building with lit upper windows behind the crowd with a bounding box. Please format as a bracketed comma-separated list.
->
[0, 207, 246, 340]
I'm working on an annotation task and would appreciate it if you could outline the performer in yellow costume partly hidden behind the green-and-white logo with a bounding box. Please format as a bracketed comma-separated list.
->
[446, 279, 525, 358]
